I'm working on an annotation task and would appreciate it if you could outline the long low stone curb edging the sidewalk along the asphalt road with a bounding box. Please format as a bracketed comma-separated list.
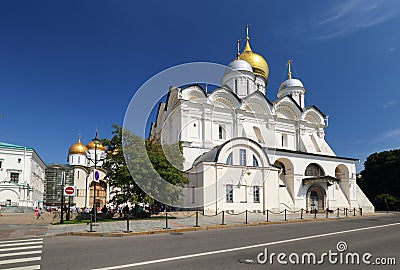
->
[46, 214, 375, 237]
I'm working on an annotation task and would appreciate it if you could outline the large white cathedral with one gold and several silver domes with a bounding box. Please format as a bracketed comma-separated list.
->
[150, 27, 374, 213]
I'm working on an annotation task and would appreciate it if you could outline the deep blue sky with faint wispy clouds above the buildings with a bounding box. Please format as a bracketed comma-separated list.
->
[0, 0, 400, 169]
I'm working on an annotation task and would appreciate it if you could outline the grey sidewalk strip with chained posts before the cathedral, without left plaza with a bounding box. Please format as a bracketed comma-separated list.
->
[46, 212, 372, 237]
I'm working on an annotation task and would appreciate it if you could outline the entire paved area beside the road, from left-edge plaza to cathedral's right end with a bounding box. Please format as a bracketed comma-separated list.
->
[0, 212, 380, 238]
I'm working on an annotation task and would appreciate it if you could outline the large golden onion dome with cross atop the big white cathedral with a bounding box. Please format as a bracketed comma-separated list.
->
[238, 25, 269, 80]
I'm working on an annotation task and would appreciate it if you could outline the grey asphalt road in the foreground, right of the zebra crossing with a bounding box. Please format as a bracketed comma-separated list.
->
[41, 213, 400, 270]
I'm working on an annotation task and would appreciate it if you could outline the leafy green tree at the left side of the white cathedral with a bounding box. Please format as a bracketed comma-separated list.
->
[103, 125, 189, 205]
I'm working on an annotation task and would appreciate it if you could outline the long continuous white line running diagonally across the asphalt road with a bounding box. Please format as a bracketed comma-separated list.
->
[92, 222, 400, 270]
